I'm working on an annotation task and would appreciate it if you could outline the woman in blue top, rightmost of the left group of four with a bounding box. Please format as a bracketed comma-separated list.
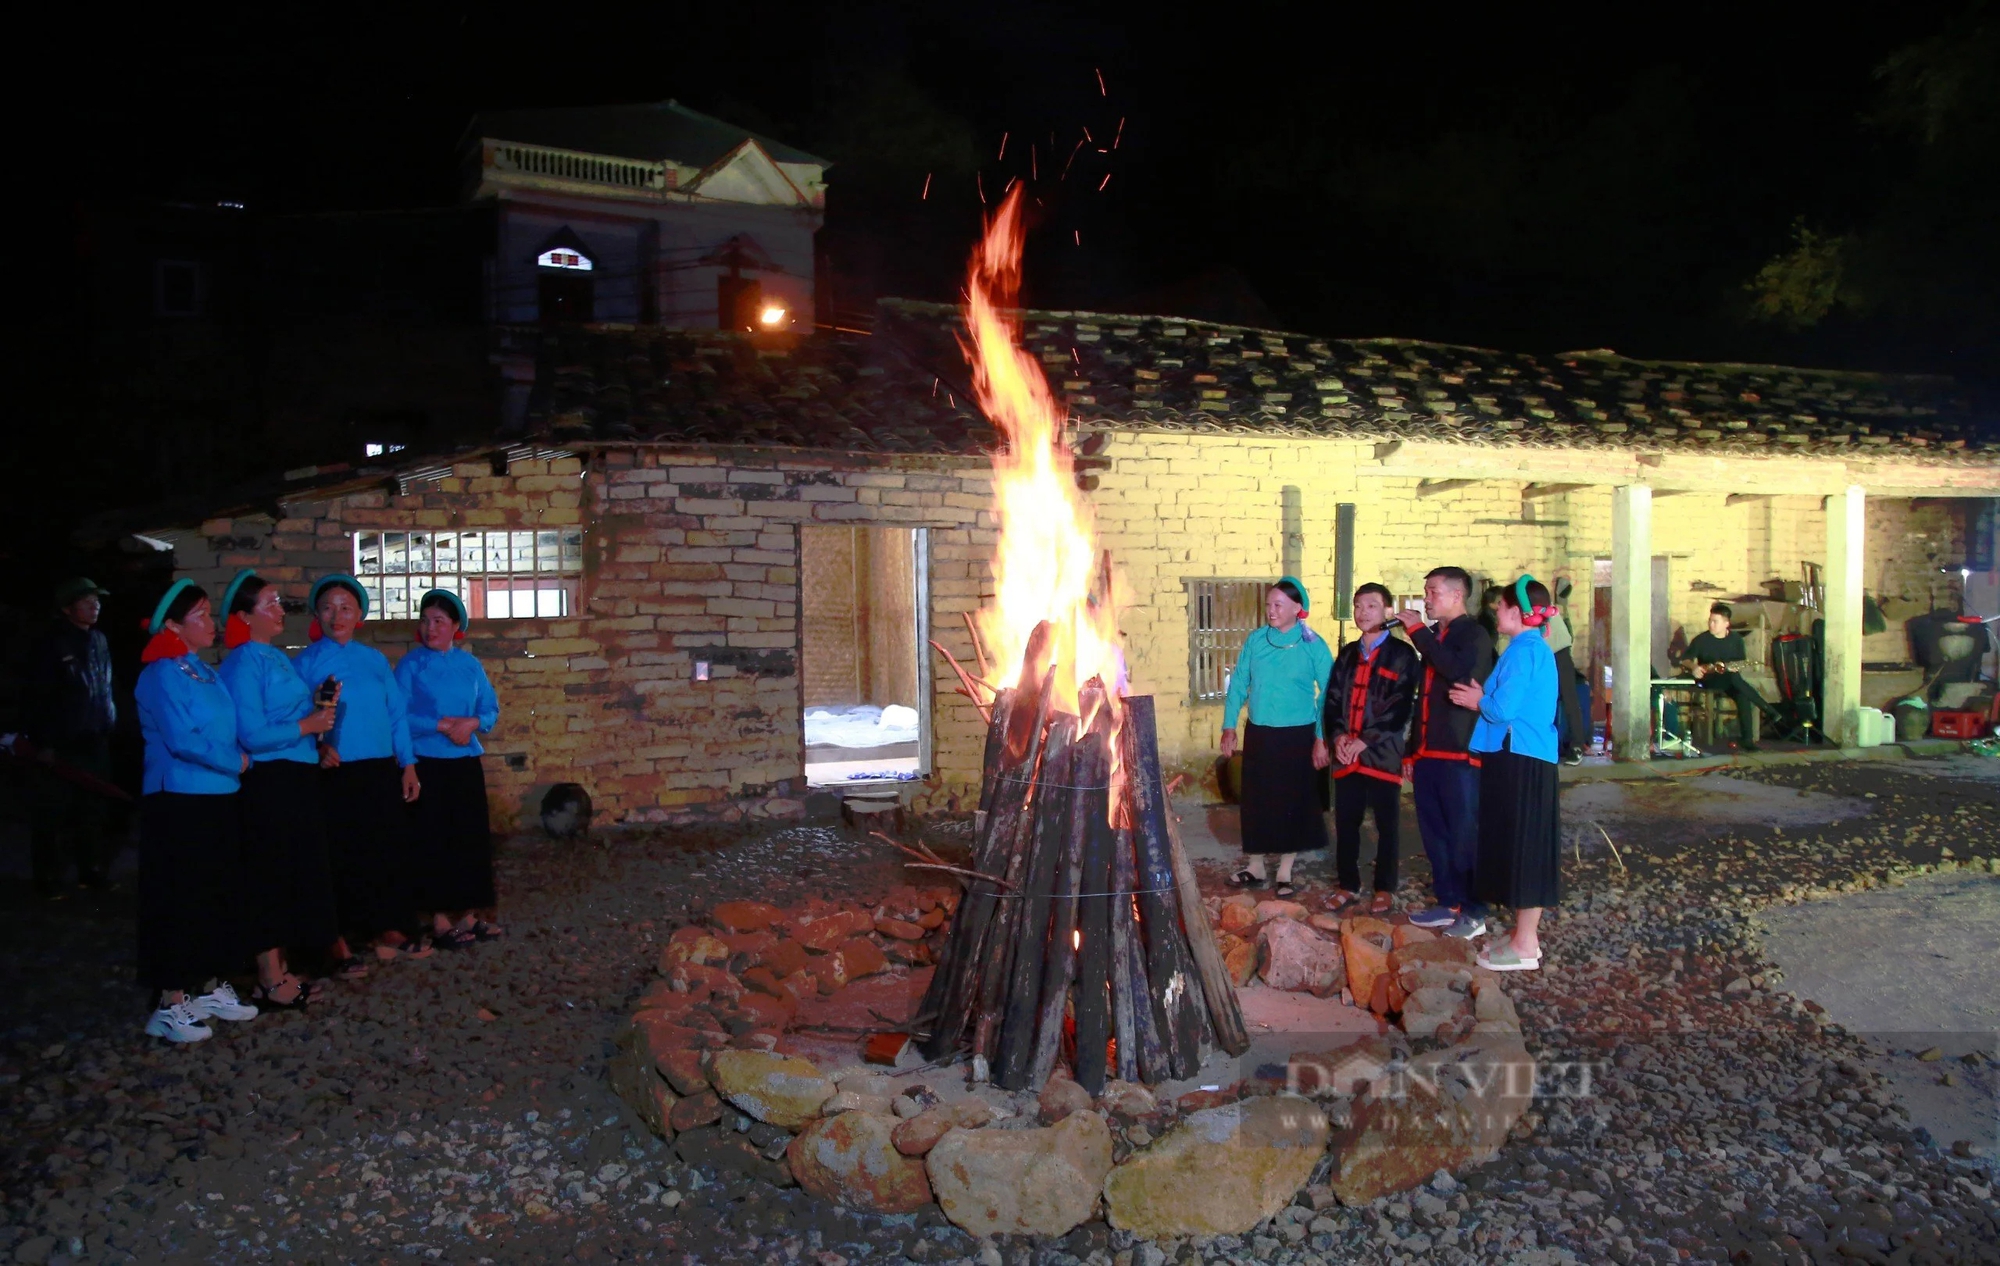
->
[396, 590, 504, 950]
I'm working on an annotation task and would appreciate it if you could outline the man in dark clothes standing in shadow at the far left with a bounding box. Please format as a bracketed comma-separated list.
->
[26, 576, 118, 896]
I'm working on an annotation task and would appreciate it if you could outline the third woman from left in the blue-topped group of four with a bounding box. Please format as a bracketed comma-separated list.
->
[296, 572, 430, 956]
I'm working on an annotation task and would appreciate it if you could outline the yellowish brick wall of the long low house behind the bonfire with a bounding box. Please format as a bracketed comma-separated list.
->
[176, 434, 1958, 822]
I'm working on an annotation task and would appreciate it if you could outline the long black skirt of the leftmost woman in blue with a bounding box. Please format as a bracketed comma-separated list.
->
[138, 792, 254, 990]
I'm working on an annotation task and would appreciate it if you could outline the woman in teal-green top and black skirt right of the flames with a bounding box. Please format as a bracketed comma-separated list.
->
[1222, 576, 1334, 896]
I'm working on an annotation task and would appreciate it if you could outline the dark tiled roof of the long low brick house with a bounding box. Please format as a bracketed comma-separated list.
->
[520, 300, 2000, 462]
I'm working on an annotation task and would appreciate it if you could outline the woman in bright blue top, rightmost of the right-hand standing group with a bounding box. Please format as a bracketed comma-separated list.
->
[1452, 576, 1562, 972]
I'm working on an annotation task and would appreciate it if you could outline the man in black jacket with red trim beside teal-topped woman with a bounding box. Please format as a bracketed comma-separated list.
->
[1326, 584, 1418, 914]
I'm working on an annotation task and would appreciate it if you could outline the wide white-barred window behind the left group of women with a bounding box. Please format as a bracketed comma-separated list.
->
[354, 528, 584, 620]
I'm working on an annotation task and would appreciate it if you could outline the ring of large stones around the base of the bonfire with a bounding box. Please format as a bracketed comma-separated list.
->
[610, 888, 1534, 1238]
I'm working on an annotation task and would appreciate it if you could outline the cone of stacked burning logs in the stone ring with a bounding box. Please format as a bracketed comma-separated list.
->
[920, 630, 1250, 1094]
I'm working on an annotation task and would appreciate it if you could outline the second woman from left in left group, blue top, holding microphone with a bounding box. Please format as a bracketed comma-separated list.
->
[218, 572, 340, 996]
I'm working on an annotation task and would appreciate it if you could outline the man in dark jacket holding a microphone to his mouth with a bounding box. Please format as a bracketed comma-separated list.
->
[1398, 568, 1494, 936]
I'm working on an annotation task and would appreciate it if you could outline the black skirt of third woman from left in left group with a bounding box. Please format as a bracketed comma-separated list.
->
[320, 756, 416, 940]
